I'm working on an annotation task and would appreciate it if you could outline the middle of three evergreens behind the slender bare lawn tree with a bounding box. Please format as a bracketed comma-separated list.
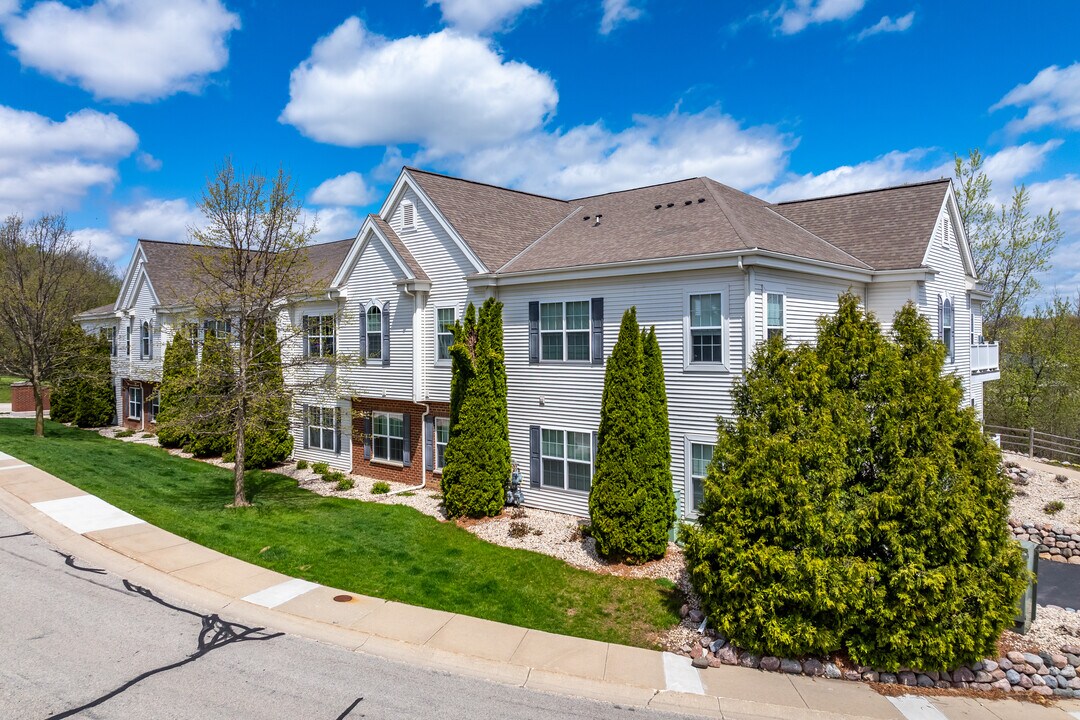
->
[184, 335, 233, 458]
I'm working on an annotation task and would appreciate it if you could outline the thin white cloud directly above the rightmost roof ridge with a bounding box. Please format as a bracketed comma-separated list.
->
[756, 149, 953, 202]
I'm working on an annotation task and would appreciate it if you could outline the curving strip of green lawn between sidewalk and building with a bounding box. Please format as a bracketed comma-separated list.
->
[0, 419, 680, 648]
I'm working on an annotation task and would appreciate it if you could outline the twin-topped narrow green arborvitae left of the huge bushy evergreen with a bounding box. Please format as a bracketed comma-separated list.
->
[589, 308, 675, 562]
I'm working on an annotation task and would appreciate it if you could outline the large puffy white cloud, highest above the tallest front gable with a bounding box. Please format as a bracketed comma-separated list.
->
[281, 17, 558, 154]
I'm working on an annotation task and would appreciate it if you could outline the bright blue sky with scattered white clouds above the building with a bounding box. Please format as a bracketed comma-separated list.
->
[0, 0, 1080, 294]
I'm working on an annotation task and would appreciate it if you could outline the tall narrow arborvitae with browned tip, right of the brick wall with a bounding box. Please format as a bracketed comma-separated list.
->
[442, 298, 510, 517]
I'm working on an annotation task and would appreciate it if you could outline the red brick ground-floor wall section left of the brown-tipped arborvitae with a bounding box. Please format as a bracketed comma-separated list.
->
[352, 397, 450, 490]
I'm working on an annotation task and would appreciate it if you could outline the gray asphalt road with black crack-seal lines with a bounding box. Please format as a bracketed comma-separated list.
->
[0, 513, 676, 720]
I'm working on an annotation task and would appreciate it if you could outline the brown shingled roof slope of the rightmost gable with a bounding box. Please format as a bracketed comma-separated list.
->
[772, 179, 950, 270]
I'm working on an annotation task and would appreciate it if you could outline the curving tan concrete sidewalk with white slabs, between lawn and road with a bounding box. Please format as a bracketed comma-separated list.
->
[0, 452, 1080, 720]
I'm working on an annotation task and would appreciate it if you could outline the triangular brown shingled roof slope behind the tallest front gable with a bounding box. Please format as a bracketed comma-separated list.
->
[406, 167, 572, 271]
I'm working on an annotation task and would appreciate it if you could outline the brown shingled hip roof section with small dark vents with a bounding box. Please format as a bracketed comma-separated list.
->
[499, 178, 868, 273]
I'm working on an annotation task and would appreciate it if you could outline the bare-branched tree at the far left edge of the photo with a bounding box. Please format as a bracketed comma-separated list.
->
[0, 215, 119, 436]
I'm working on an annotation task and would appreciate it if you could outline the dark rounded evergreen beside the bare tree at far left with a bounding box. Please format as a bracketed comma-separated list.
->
[49, 325, 117, 427]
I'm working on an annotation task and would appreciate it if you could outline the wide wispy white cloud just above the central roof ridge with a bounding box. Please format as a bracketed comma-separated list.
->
[453, 109, 792, 198]
